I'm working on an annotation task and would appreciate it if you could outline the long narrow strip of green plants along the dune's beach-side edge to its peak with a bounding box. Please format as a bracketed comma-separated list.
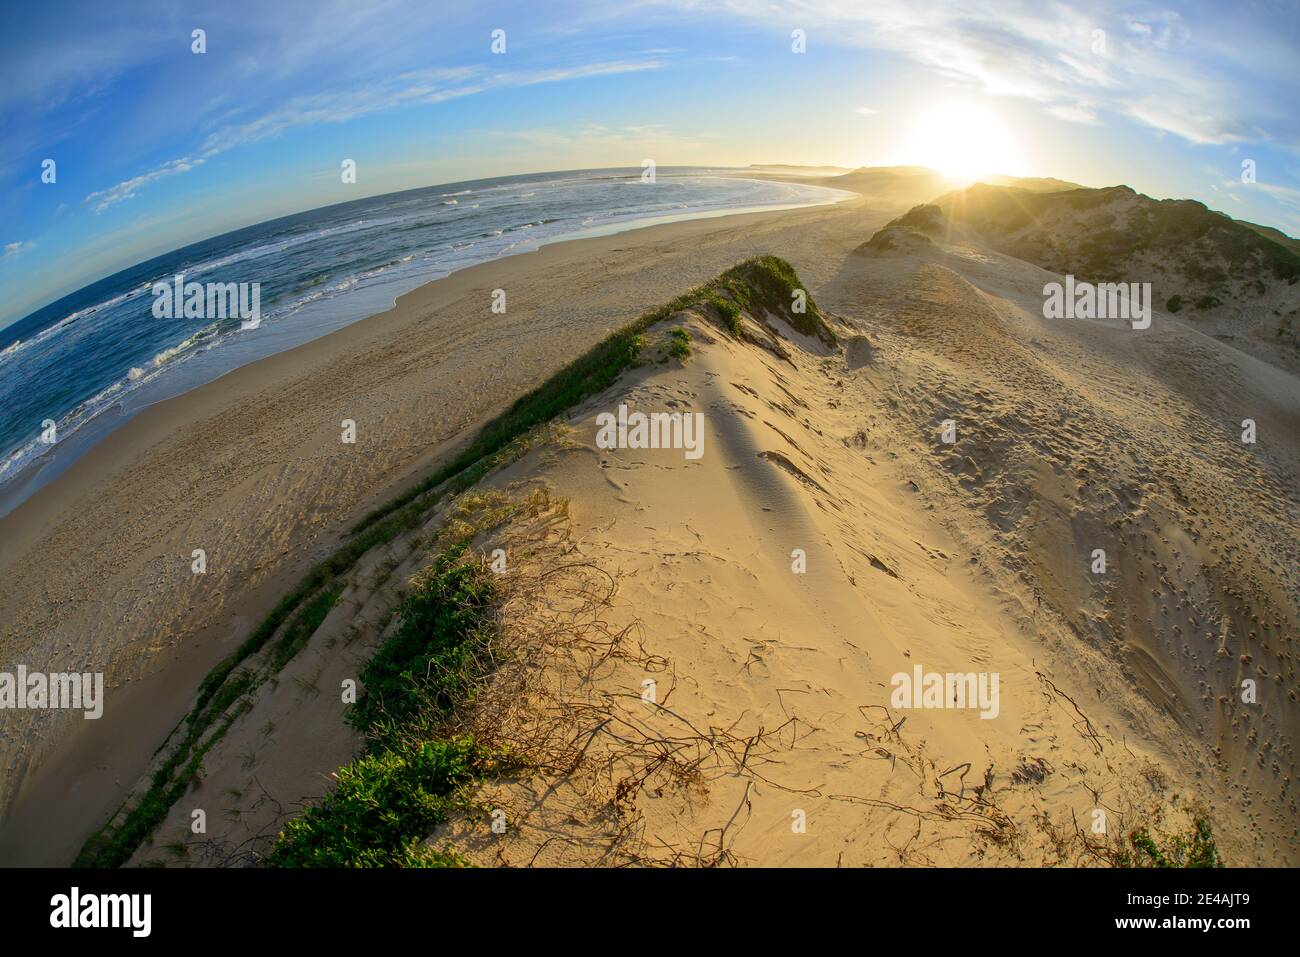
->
[74, 256, 816, 867]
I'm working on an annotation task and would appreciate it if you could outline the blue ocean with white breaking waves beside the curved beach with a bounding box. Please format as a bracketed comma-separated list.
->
[0, 168, 848, 515]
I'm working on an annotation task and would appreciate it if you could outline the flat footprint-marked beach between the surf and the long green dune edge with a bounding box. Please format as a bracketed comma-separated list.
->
[0, 191, 893, 865]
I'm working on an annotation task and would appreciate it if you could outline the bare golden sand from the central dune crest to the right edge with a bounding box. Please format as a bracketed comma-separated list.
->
[441, 254, 1300, 865]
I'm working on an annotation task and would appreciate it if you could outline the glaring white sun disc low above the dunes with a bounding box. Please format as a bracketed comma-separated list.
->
[906, 103, 1022, 183]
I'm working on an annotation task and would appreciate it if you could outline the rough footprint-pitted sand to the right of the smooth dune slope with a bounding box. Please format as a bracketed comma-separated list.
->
[811, 244, 1300, 863]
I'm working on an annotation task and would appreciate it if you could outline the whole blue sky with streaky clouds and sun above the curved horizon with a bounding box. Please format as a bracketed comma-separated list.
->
[0, 0, 1300, 328]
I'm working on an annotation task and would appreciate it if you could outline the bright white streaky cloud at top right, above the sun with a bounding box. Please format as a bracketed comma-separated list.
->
[663, 0, 1274, 147]
